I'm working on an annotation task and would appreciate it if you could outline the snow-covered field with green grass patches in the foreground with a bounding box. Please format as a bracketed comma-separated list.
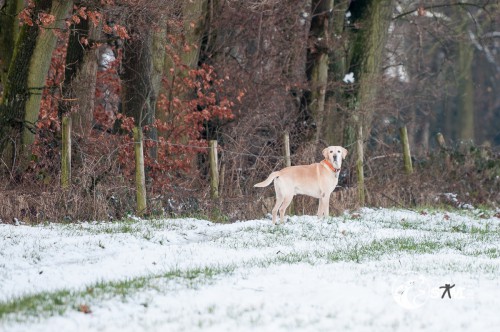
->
[0, 209, 500, 332]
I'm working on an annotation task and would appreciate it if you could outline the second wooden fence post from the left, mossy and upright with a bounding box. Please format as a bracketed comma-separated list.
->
[133, 127, 147, 216]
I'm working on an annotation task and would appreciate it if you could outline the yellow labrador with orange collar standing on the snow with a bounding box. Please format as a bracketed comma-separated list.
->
[254, 146, 347, 223]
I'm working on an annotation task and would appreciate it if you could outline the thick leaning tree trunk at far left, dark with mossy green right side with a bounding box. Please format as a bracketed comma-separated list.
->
[0, 0, 73, 171]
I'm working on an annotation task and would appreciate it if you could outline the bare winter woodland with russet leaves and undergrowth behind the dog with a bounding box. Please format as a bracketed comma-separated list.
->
[0, 0, 500, 222]
